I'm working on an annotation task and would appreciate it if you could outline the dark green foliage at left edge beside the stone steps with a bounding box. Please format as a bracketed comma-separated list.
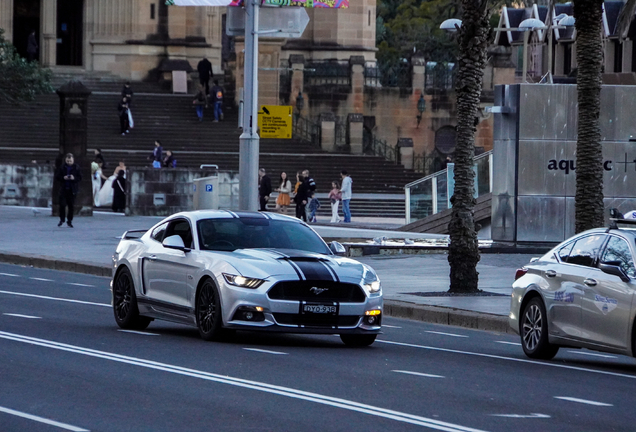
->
[0, 28, 53, 102]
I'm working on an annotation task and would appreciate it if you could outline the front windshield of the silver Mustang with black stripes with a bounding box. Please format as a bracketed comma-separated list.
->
[197, 218, 331, 255]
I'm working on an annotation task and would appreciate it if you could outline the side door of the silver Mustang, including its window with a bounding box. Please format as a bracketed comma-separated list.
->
[143, 219, 192, 307]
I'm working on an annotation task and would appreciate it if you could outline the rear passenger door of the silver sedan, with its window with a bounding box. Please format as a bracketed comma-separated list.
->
[544, 234, 606, 339]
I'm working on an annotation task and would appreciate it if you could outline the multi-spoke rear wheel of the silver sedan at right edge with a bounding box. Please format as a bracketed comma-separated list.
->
[520, 297, 559, 360]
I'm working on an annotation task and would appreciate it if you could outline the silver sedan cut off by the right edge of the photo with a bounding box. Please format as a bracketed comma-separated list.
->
[509, 228, 636, 359]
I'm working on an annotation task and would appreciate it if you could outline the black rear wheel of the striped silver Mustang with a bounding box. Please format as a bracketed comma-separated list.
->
[113, 267, 152, 330]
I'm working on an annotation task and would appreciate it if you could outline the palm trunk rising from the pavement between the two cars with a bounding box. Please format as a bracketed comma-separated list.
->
[448, 0, 489, 293]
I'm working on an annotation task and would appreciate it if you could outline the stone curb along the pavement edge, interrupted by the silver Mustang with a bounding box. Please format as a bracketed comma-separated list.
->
[0, 252, 516, 334]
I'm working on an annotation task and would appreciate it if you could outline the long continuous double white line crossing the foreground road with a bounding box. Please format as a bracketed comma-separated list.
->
[0, 331, 483, 432]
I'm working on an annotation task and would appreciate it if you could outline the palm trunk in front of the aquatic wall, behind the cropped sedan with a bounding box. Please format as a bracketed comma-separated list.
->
[574, 0, 604, 233]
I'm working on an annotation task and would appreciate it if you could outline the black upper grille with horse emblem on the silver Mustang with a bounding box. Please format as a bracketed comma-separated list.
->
[267, 281, 366, 303]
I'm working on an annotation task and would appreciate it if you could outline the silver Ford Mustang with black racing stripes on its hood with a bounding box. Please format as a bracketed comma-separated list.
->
[111, 210, 382, 346]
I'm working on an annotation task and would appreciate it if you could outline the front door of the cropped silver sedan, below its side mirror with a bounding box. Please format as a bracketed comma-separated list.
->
[582, 235, 636, 349]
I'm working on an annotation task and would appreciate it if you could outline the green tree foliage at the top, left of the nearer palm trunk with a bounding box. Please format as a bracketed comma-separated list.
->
[376, 0, 459, 63]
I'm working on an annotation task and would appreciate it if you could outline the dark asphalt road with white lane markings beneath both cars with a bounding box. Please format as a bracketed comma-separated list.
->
[0, 265, 636, 432]
